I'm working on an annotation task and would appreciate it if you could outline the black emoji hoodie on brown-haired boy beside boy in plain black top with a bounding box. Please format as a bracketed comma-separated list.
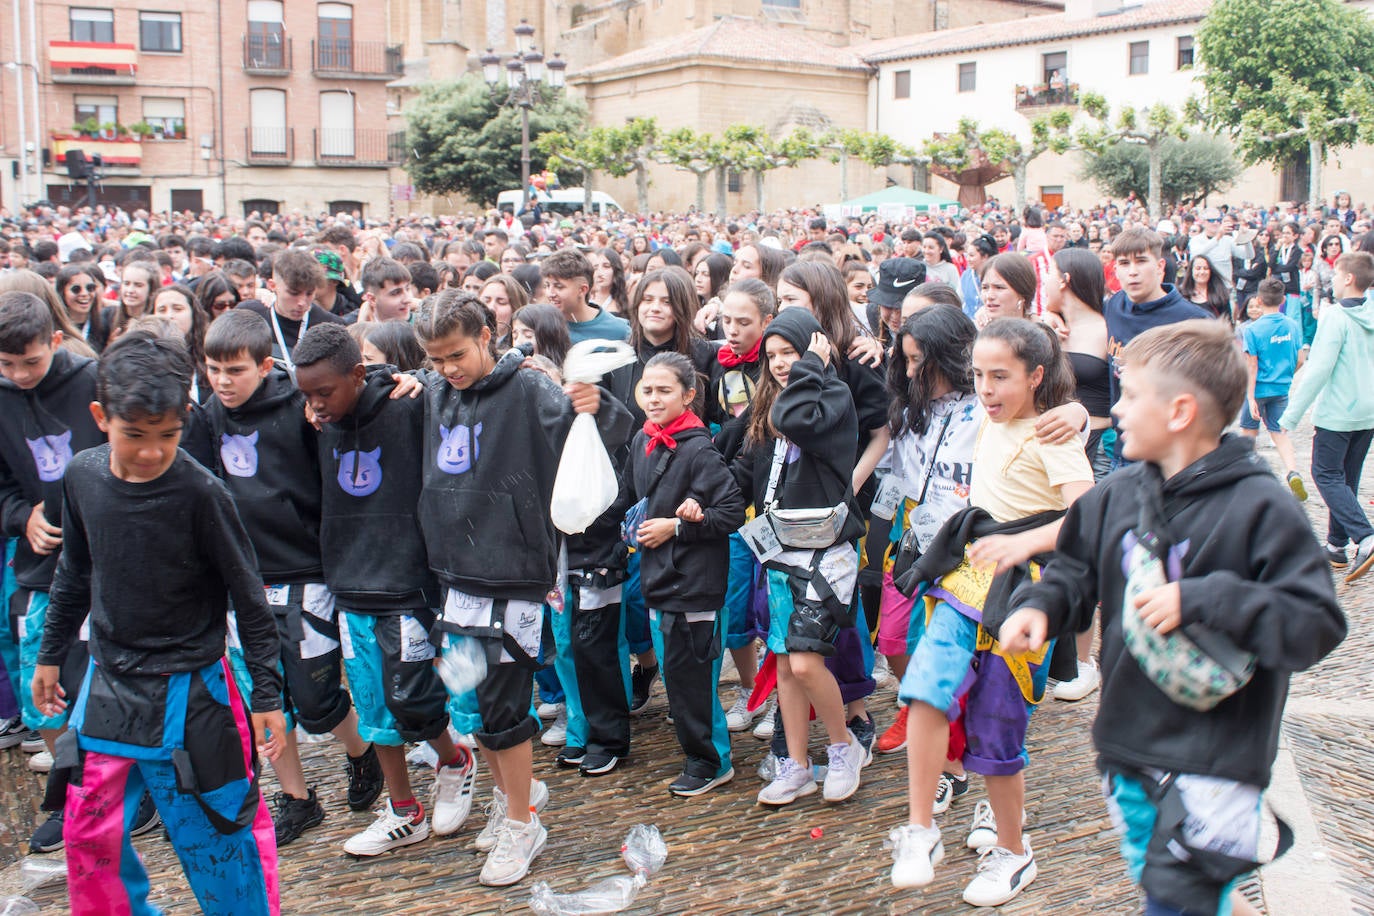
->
[205, 365, 324, 585]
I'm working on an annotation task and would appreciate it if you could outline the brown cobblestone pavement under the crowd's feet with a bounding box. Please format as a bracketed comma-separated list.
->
[0, 420, 1374, 916]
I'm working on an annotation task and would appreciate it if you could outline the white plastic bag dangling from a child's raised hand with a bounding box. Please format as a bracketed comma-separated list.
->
[550, 341, 636, 534]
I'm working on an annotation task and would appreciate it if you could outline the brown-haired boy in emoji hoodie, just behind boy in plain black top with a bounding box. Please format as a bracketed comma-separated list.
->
[205, 310, 382, 846]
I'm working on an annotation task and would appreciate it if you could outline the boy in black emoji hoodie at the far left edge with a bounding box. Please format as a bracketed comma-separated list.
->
[0, 293, 108, 853]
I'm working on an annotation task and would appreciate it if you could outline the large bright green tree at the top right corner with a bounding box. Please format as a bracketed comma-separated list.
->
[1197, 0, 1374, 207]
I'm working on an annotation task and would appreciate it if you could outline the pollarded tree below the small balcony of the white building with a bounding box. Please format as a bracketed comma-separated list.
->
[925, 108, 1073, 211]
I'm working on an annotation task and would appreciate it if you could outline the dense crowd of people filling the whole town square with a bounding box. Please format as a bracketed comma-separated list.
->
[0, 192, 1357, 915]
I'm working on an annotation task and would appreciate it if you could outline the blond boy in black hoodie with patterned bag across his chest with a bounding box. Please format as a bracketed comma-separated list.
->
[999, 320, 1345, 913]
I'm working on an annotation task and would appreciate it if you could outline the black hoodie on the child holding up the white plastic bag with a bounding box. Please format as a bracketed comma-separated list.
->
[419, 350, 632, 602]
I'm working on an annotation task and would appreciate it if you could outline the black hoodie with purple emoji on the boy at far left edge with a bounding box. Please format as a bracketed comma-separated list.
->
[0, 347, 104, 590]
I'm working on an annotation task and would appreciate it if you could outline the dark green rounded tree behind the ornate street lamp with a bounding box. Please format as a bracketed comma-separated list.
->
[405, 74, 587, 205]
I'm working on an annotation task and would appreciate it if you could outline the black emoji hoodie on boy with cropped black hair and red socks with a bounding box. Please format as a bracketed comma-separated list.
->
[319, 367, 438, 612]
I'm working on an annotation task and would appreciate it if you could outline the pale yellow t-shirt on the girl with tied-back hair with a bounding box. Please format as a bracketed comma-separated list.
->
[969, 417, 1092, 522]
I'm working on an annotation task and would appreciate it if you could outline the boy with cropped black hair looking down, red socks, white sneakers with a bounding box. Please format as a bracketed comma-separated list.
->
[294, 324, 486, 856]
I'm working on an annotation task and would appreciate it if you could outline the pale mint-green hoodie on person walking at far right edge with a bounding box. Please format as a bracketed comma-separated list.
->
[1279, 297, 1374, 433]
